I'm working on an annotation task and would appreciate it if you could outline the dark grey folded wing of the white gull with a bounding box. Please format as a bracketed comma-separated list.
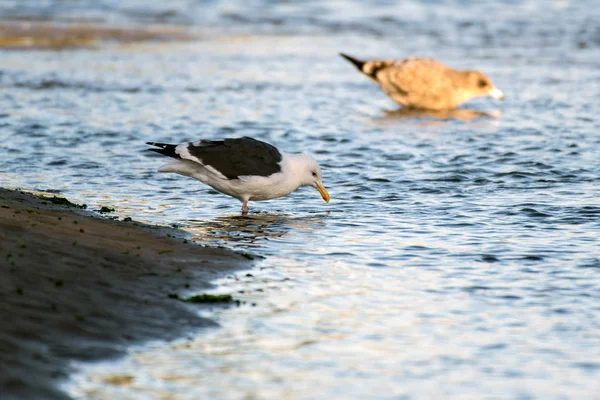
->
[176, 137, 282, 179]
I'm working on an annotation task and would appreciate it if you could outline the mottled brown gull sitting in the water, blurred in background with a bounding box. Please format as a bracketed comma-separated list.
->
[340, 53, 504, 110]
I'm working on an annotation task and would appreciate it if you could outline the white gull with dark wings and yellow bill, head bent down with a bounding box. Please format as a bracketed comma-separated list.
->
[146, 137, 330, 215]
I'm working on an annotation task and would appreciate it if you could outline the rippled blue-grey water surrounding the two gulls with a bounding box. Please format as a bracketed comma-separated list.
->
[0, 0, 600, 399]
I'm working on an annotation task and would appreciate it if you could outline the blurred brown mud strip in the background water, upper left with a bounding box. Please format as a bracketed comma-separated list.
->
[0, 20, 196, 49]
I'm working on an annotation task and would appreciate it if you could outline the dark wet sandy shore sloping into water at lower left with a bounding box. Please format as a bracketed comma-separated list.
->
[0, 189, 251, 400]
